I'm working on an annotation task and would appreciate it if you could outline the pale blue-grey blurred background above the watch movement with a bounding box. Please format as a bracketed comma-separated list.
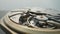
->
[0, 0, 60, 10]
